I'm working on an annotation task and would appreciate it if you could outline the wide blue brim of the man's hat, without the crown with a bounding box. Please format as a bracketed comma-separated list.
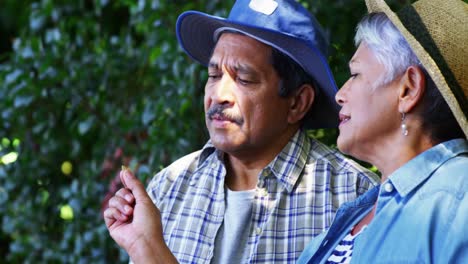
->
[176, 11, 339, 128]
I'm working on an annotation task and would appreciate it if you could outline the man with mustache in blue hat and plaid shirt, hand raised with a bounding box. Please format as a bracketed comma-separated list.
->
[104, 0, 378, 263]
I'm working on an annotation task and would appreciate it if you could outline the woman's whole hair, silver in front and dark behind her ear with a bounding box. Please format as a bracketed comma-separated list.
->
[354, 13, 465, 143]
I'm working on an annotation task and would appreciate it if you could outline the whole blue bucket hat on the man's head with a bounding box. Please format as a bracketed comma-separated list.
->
[176, 0, 339, 128]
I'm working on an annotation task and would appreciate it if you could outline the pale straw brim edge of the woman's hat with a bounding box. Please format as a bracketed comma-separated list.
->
[366, 0, 468, 137]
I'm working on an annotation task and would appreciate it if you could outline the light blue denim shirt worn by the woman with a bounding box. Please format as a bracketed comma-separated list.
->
[298, 139, 468, 263]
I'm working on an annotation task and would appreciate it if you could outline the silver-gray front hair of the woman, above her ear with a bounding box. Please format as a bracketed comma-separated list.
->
[354, 13, 420, 87]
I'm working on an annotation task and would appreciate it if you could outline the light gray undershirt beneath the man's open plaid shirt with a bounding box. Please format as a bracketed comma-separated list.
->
[211, 188, 255, 264]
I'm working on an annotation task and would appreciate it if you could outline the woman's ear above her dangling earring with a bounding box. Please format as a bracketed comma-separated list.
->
[398, 66, 426, 113]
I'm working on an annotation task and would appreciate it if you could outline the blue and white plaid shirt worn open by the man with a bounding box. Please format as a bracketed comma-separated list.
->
[147, 131, 379, 263]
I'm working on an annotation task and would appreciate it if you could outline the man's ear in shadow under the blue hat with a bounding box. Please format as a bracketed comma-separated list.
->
[288, 84, 315, 124]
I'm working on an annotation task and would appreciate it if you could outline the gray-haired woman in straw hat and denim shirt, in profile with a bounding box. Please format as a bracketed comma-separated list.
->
[299, 0, 468, 263]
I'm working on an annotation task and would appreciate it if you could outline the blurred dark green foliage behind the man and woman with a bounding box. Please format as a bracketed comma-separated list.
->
[0, 0, 406, 263]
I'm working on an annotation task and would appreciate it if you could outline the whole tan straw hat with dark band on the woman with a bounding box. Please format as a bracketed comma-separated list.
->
[366, 0, 468, 137]
